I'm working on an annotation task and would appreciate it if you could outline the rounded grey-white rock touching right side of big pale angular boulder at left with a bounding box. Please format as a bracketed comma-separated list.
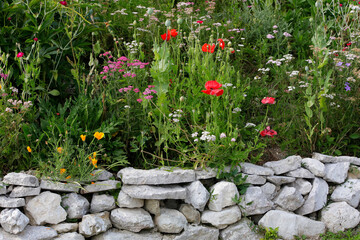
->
[62, 193, 90, 219]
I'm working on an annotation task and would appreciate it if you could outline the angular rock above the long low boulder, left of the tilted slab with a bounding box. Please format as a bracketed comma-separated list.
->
[274, 186, 305, 212]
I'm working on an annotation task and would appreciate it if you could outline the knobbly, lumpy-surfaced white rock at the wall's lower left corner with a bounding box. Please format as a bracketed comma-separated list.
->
[0, 208, 29, 234]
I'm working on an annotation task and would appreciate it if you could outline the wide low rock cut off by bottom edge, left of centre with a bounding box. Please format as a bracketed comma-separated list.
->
[92, 228, 162, 240]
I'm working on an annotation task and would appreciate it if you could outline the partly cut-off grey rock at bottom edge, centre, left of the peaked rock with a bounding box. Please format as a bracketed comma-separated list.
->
[174, 225, 219, 240]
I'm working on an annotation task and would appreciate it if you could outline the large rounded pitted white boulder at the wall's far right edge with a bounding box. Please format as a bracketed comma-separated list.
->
[321, 202, 360, 233]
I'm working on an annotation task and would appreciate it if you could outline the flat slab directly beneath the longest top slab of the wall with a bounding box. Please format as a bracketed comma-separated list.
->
[121, 185, 186, 200]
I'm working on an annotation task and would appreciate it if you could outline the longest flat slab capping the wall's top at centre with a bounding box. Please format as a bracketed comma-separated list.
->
[117, 167, 196, 185]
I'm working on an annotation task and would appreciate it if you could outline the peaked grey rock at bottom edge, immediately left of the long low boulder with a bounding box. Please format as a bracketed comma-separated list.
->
[220, 218, 264, 240]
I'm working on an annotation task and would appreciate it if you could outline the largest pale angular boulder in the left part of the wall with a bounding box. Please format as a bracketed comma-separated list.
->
[25, 191, 67, 225]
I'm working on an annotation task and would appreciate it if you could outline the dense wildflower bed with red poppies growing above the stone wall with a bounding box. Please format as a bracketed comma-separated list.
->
[0, 0, 360, 181]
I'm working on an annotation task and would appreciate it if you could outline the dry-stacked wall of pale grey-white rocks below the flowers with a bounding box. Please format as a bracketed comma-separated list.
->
[0, 153, 360, 240]
